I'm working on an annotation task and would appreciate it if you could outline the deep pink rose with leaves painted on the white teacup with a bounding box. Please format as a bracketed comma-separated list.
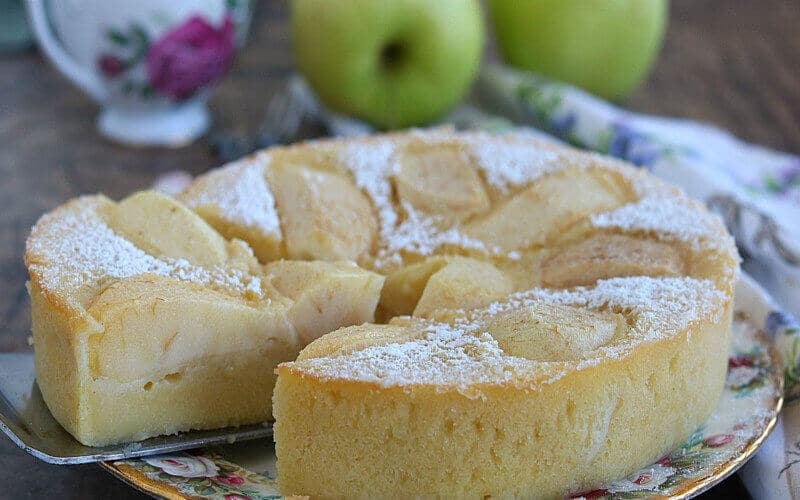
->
[97, 14, 235, 101]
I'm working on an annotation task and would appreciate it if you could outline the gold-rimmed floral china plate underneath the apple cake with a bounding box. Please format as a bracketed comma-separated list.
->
[100, 276, 783, 500]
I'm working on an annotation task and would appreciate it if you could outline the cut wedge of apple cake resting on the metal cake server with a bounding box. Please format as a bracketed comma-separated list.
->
[26, 192, 382, 446]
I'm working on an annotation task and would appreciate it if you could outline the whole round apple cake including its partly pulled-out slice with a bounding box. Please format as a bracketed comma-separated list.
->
[26, 130, 738, 497]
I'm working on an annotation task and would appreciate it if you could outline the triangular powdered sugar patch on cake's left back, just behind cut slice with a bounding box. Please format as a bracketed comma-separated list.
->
[182, 153, 281, 238]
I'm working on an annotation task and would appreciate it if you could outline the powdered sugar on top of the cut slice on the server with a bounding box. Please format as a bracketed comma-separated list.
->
[28, 197, 262, 297]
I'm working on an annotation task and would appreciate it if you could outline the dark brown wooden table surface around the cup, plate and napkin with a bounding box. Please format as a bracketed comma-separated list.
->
[0, 0, 800, 500]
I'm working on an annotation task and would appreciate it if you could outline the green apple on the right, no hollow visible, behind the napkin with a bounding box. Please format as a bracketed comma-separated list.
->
[488, 0, 667, 99]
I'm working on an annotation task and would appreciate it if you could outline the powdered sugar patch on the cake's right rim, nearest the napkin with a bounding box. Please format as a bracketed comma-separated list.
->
[591, 196, 722, 248]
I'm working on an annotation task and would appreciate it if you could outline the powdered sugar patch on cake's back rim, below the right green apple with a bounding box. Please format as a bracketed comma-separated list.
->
[467, 136, 564, 194]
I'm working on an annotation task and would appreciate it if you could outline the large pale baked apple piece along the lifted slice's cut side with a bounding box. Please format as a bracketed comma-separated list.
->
[87, 274, 301, 381]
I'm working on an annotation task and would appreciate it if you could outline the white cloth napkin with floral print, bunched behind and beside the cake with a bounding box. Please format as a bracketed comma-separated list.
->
[282, 65, 800, 498]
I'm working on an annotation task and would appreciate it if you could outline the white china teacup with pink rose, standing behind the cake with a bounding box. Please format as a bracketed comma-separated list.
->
[26, 0, 247, 146]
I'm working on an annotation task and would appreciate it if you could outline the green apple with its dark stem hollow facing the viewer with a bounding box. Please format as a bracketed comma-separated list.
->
[291, 0, 484, 128]
